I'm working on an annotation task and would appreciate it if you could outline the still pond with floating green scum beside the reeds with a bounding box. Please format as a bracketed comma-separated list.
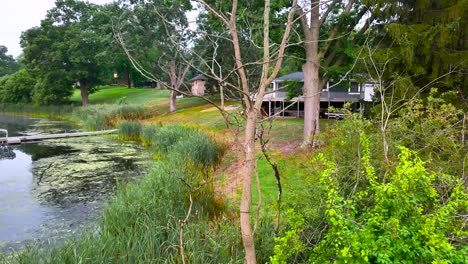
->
[0, 114, 148, 255]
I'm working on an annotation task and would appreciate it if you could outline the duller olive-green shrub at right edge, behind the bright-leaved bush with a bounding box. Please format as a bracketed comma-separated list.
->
[389, 89, 468, 175]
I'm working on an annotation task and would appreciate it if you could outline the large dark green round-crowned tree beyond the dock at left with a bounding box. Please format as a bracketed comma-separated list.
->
[21, 0, 109, 106]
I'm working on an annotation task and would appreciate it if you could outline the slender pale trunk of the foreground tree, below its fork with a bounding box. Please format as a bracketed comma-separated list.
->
[240, 108, 257, 264]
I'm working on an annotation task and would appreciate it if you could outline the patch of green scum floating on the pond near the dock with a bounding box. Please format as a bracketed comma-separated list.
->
[32, 137, 148, 206]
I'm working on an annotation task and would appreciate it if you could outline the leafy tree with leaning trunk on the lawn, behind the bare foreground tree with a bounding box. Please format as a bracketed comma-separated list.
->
[115, 0, 192, 112]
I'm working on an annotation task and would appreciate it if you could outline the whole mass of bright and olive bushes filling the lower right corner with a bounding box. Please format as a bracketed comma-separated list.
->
[272, 109, 468, 263]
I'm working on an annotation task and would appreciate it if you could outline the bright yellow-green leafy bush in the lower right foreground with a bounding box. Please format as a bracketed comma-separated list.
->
[311, 133, 468, 263]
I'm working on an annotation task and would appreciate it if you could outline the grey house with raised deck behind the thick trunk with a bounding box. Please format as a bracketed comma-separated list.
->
[262, 72, 374, 117]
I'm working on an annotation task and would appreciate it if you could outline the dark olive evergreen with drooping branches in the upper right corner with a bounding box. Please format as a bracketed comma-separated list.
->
[379, 0, 468, 107]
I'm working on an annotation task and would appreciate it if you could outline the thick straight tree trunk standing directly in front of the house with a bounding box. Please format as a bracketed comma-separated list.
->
[300, 0, 321, 145]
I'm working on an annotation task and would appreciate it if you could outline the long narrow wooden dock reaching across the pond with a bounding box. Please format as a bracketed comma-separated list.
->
[0, 129, 117, 145]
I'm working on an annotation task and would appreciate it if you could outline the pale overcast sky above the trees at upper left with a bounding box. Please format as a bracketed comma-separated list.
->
[0, 0, 112, 57]
